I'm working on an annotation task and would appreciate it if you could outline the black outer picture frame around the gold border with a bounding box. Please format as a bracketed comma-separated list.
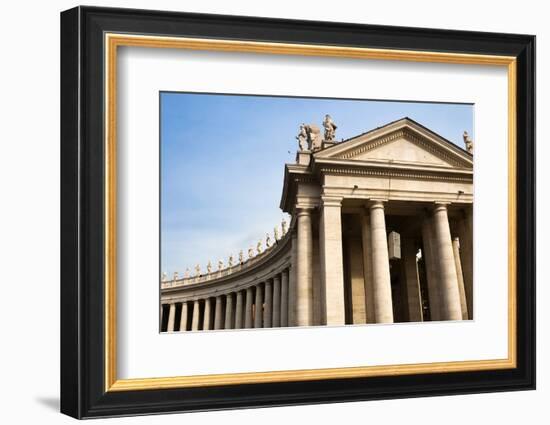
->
[61, 7, 535, 418]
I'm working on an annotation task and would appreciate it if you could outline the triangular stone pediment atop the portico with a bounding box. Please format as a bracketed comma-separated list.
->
[314, 118, 473, 168]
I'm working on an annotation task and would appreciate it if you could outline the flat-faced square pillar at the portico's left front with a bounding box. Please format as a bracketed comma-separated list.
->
[319, 197, 346, 325]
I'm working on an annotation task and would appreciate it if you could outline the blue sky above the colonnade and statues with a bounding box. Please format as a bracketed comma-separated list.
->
[160, 92, 473, 276]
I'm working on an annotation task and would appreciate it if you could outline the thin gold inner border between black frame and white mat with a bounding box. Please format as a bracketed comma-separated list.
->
[104, 33, 517, 392]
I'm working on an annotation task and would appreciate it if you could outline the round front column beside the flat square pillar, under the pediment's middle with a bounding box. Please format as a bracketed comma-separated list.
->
[370, 201, 393, 323]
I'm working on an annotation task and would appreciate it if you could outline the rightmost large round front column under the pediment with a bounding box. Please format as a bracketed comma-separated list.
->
[433, 203, 462, 320]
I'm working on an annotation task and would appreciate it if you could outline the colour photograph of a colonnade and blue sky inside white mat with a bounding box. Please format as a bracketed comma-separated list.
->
[158, 91, 475, 332]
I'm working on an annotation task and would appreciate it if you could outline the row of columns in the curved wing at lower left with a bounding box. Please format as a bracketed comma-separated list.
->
[161, 268, 292, 332]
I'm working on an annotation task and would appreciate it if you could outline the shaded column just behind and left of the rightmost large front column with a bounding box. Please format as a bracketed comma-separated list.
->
[422, 216, 441, 321]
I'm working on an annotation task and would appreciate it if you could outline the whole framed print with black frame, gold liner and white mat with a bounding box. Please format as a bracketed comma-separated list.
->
[61, 7, 535, 418]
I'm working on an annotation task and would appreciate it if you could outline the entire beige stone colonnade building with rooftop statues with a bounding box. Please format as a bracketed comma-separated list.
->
[161, 117, 474, 332]
